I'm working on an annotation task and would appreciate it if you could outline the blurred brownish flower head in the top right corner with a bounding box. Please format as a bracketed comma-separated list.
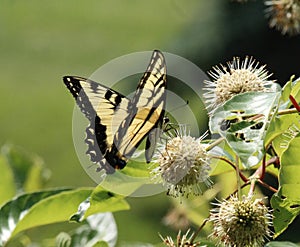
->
[265, 0, 300, 35]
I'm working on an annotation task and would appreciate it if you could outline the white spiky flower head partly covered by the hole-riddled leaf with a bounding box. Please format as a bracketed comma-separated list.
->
[204, 56, 274, 112]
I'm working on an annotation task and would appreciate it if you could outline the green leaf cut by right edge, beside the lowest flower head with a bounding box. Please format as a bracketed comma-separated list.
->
[271, 135, 300, 237]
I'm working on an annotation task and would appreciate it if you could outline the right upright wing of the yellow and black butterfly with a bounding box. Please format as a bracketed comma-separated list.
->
[114, 51, 166, 162]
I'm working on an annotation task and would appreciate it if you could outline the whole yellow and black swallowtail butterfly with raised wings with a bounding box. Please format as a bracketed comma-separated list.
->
[63, 51, 166, 173]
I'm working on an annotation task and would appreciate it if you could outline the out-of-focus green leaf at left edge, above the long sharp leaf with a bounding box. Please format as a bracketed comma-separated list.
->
[1, 145, 50, 192]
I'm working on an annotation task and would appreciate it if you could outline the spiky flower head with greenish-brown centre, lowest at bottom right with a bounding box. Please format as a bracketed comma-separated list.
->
[210, 196, 272, 247]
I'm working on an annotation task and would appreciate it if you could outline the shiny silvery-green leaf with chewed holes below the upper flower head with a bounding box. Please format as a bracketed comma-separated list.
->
[209, 92, 279, 168]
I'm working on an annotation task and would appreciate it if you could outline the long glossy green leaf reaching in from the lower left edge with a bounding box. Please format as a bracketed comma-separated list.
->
[0, 189, 92, 246]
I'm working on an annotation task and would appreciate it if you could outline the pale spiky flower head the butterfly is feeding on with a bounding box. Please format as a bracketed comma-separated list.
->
[151, 126, 211, 197]
